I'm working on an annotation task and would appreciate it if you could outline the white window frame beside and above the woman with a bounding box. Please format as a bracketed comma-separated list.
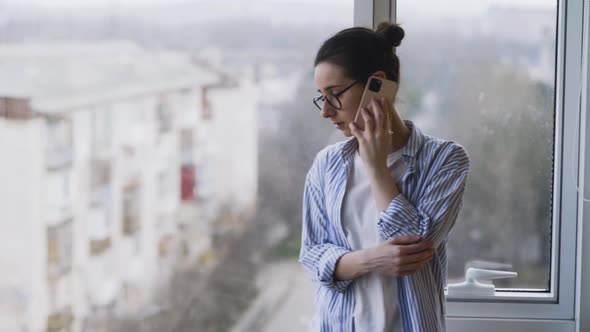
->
[354, 0, 590, 332]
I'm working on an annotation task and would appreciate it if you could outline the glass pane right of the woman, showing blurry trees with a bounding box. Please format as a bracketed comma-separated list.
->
[397, 0, 557, 291]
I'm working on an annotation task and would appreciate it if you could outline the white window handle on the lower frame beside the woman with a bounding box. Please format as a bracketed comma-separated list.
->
[447, 267, 518, 297]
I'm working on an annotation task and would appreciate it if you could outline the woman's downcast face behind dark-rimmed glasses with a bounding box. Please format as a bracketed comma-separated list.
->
[314, 62, 364, 137]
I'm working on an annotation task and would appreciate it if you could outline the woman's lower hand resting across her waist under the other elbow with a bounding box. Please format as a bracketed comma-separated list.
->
[365, 236, 435, 277]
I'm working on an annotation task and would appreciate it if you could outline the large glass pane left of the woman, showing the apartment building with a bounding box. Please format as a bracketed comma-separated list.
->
[0, 0, 354, 332]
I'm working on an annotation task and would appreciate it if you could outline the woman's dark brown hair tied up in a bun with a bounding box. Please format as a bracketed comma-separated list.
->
[314, 22, 405, 83]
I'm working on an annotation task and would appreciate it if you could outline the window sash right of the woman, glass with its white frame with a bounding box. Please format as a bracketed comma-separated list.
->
[391, 0, 582, 331]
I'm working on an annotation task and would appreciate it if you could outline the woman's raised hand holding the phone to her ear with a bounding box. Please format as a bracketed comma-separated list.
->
[349, 98, 393, 173]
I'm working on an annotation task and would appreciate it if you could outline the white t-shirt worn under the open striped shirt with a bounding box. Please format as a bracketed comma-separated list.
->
[342, 149, 407, 332]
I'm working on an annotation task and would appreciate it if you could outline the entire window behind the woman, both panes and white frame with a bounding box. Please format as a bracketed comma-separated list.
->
[10, 0, 587, 332]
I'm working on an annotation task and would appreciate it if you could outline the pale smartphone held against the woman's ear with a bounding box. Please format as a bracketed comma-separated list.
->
[354, 76, 399, 131]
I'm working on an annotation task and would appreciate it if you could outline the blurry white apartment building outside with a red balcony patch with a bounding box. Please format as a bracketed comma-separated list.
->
[0, 42, 256, 331]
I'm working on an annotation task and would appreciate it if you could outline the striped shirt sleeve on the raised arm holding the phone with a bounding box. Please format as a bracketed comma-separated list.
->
[377, 145, 469, 246]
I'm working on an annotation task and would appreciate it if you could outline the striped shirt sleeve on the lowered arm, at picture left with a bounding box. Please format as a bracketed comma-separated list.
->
[299, 153, 352, 292]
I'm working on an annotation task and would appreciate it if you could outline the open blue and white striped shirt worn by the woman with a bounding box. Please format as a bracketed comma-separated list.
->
[299, 121, 469, 332]
